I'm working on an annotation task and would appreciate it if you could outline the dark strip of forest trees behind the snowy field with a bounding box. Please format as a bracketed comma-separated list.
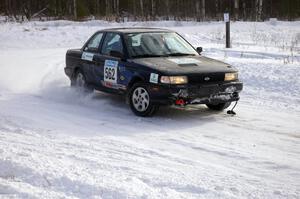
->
[0, 0, 300, 21]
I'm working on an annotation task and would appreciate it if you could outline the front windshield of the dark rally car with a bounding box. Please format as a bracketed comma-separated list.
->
[125, 32, 198, 58]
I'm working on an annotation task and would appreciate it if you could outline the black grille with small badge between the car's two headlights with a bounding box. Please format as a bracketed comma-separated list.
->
[188, 73, 225, 84]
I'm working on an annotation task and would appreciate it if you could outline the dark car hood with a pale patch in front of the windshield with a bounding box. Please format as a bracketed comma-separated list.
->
[131, 56, 236, 75]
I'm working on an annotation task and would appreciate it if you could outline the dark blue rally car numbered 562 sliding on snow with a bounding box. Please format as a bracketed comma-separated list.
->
[65, 28, 243, 116]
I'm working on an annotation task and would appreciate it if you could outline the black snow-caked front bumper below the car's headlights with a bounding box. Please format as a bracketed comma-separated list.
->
[150, 81, 243, 105]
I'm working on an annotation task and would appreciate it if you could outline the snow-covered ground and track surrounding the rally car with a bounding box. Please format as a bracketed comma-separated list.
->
[0, 21, 300, 199]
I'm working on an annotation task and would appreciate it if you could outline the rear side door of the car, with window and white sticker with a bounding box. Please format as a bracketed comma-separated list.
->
[81, 32, 104, 84]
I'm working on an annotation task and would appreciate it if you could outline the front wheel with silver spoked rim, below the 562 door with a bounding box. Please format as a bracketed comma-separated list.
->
[128, 82, 159, 117]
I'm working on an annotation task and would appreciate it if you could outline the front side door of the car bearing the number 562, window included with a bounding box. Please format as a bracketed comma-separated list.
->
[94, 32, 124, 89]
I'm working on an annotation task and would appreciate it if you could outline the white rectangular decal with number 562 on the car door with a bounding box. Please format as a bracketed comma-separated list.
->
[104, 60, 118, 84]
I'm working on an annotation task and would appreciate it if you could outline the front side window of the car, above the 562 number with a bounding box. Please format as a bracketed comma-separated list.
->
[101, 33, 123, 55]
